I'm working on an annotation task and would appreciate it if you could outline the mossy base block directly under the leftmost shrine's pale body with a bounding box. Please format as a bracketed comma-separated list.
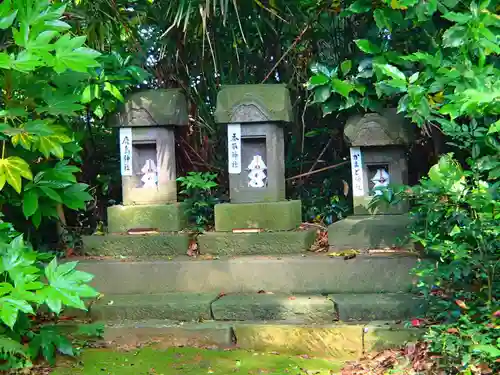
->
[108, 203, 187, 233]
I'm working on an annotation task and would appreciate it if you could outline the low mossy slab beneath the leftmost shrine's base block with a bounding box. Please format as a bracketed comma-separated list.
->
[82, 233, 189, 257]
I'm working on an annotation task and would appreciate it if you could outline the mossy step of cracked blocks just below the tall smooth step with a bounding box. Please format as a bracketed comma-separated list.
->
[73, 293, 423, 324]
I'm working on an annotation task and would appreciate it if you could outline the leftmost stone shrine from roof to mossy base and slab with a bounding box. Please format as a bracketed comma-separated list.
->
[84, 89, 188, 255]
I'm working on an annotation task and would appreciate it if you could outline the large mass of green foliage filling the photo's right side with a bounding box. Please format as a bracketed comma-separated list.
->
[307, 0, 500, 374]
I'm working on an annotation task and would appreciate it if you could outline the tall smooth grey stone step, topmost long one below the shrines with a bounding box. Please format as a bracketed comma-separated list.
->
[78, 254, 417, 294]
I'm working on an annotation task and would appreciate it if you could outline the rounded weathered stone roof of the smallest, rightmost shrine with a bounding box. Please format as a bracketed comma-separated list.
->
[344, 108, 413, 147]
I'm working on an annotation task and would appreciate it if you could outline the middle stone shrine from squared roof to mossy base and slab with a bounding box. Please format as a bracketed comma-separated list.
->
[198, 85, 313, 253]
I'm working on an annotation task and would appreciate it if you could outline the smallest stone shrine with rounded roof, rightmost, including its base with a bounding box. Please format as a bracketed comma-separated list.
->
[328, 109, 413, 253]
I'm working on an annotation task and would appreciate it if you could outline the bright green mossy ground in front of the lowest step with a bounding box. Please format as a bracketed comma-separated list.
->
[53, 348, 341, 375]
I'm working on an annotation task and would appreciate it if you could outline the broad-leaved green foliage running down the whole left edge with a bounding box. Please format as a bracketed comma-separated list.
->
[0, 0, 118, 369]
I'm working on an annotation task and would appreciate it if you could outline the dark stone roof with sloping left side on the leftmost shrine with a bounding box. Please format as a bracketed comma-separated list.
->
[111, 89, 189, 127]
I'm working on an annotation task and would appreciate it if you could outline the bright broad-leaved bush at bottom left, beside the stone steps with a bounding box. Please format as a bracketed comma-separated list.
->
[0, 235, 98, 368]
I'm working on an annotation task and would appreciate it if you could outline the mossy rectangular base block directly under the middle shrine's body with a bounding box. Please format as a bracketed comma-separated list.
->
[215, 200, 302, 232]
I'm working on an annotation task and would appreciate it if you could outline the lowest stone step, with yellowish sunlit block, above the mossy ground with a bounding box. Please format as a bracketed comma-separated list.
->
[79, 320, 422, 361]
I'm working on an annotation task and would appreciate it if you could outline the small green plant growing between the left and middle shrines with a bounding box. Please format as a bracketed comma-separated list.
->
[177, 172, 218, 232]
